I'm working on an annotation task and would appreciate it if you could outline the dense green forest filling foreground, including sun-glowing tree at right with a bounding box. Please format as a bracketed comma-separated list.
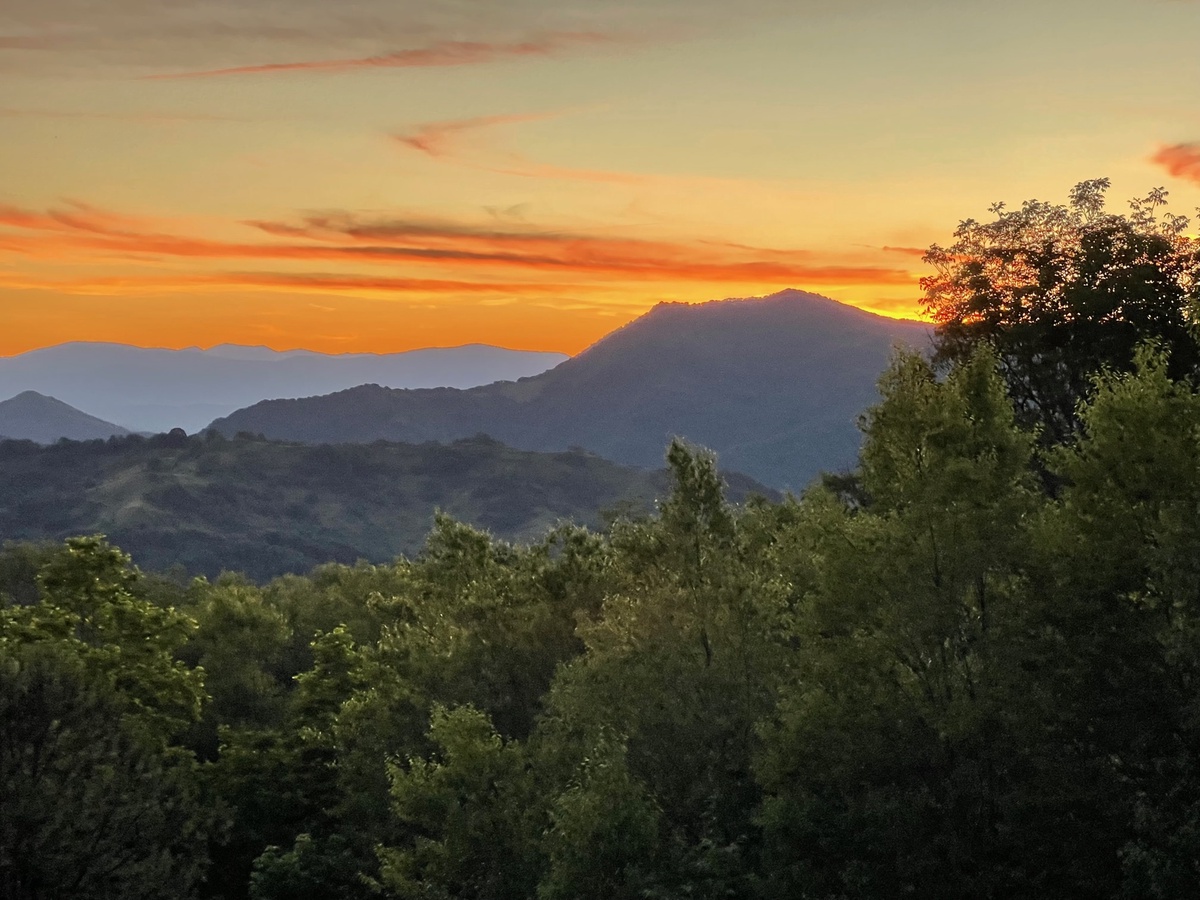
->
[7, 181, 1200, 900]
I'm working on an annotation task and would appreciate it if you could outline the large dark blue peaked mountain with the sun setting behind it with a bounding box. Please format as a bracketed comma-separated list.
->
[211, 290, 930, 490]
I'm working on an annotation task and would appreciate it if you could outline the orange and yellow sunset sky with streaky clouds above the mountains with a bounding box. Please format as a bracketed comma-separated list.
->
[0, 0, 1200, 355]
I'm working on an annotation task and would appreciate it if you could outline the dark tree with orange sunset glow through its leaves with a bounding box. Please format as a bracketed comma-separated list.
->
[922, 179, 1200, 444]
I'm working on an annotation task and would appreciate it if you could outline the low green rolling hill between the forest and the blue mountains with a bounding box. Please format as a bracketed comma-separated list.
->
[0, 432, 770, 580]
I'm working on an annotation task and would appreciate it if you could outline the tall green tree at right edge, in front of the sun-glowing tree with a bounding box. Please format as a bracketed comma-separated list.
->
[1037, 348, 1200, 898]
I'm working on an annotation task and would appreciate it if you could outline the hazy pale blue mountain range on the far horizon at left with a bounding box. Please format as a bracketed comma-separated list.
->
[0, 342, 566, 432]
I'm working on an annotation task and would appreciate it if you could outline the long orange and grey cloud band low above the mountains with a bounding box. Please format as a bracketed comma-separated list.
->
[0, 203, 916, 292]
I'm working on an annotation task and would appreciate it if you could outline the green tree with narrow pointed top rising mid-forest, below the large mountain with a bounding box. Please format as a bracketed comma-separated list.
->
[530, 440, 788, 898]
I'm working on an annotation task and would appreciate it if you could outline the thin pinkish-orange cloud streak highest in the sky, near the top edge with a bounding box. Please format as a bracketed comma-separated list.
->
[146, 31, 620, 80]
